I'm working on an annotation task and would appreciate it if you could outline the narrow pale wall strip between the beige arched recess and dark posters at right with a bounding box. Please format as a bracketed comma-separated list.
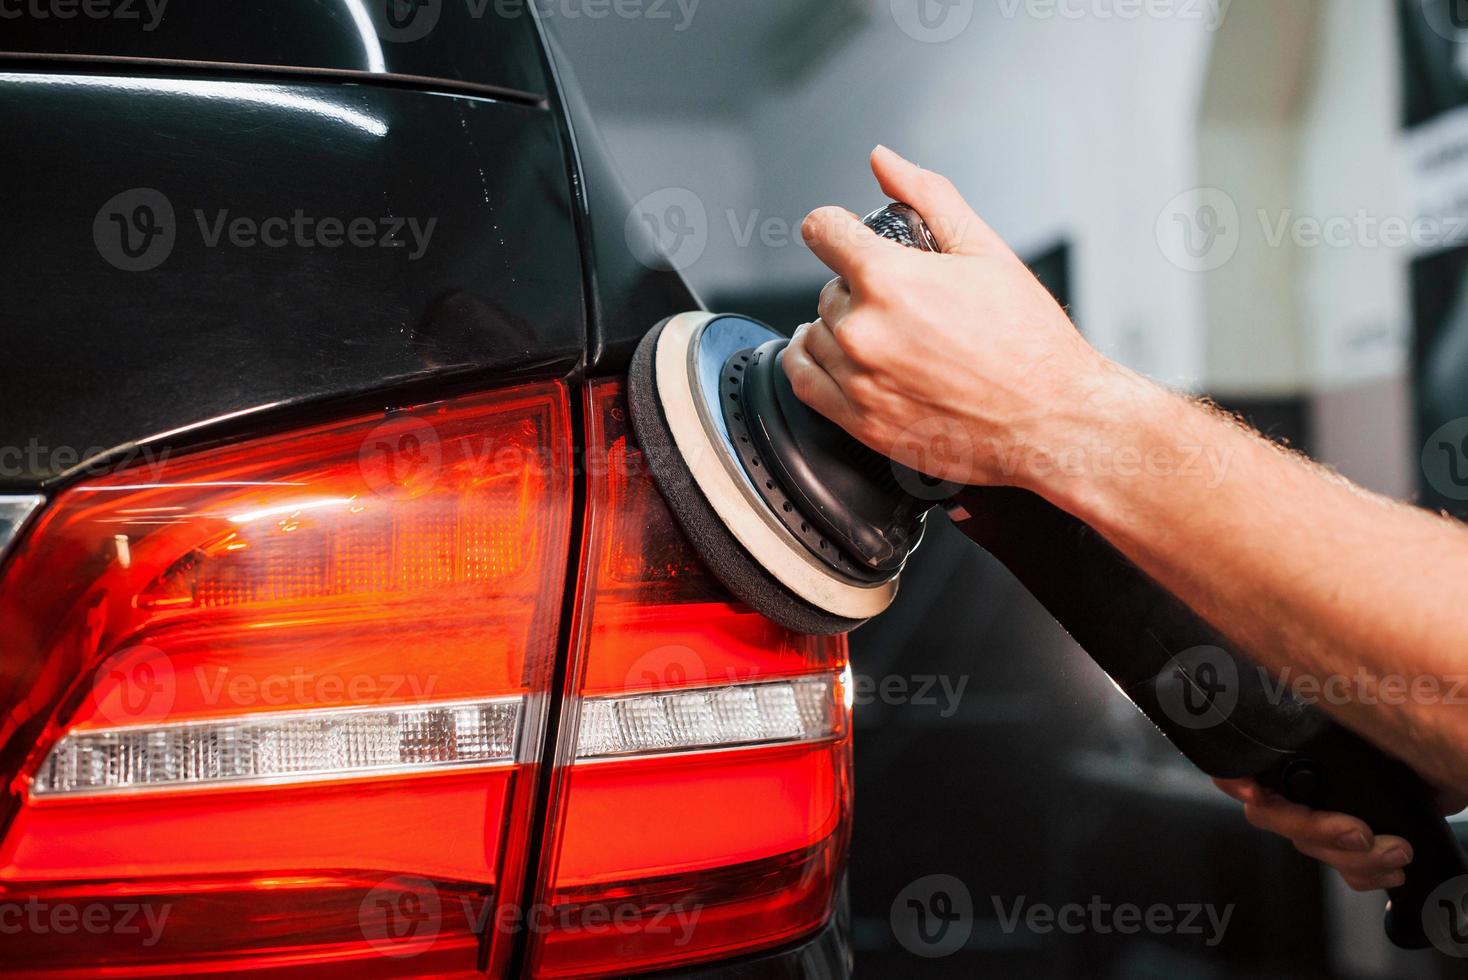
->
[1293, 0, 1418, 499]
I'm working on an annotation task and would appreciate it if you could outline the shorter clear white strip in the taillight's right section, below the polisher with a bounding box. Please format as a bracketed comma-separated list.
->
[575, 673, 846, 761]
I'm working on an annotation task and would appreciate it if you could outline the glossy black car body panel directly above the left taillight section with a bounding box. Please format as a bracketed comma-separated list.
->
[0, 72, 586, 486]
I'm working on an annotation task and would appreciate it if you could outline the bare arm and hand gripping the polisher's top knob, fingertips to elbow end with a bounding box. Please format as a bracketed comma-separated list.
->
[784, 150, 1468, 789]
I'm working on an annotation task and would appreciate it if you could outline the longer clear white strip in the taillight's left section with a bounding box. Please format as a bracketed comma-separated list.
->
[31, 697, 524, 797]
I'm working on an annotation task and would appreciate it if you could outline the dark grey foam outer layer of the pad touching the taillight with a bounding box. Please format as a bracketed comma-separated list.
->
[627, 317, 866, 635]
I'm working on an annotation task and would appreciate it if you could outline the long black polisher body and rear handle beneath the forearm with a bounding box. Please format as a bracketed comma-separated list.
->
[948, 487, 1468, 951]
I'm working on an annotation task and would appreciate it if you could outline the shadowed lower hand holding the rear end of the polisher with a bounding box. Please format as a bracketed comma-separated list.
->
[1213, 779, 1468, 892]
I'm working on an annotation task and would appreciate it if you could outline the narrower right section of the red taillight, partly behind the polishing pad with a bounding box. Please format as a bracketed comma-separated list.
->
[530, 381, 850, 977]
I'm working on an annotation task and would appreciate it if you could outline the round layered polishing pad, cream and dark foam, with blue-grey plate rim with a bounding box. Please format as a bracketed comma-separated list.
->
[627, 312, 897, 634]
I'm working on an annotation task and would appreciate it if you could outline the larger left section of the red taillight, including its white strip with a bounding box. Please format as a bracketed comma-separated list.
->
[0, 384, 571, 976]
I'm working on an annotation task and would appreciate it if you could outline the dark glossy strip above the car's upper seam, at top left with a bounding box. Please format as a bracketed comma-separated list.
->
[0, 0, 546, 98]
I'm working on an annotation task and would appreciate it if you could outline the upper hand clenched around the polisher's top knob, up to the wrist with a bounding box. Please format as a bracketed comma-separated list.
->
[784, 147, 1144, 486]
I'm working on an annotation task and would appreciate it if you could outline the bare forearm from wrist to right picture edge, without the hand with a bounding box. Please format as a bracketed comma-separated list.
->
[1017, 367, 1468, 789]
